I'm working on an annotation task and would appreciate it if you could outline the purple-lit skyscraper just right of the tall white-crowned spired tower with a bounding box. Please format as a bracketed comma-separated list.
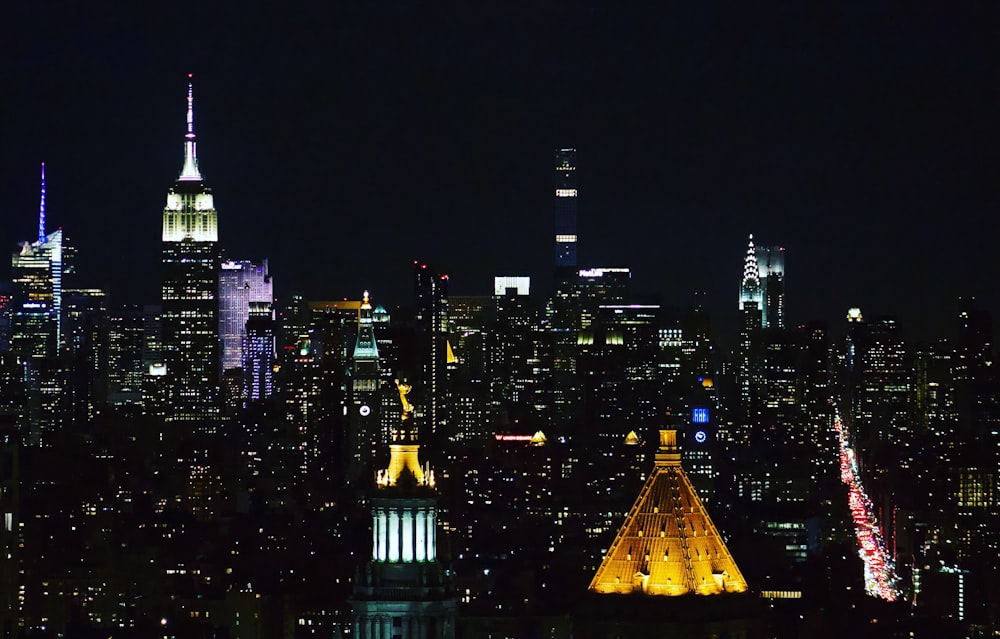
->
[219, 260, 274, 372]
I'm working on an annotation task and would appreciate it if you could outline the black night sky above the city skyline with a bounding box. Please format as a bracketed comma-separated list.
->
[0, 0, 1000, 338]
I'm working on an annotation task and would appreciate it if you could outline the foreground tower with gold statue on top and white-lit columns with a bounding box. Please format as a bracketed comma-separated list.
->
[351, 381, 457, 639]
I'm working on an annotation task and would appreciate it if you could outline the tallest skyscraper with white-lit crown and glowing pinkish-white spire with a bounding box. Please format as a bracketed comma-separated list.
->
[162, 75, 219, 428]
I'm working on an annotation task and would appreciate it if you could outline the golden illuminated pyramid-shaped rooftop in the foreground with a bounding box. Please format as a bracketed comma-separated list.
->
[590, 430, 747, 596]
